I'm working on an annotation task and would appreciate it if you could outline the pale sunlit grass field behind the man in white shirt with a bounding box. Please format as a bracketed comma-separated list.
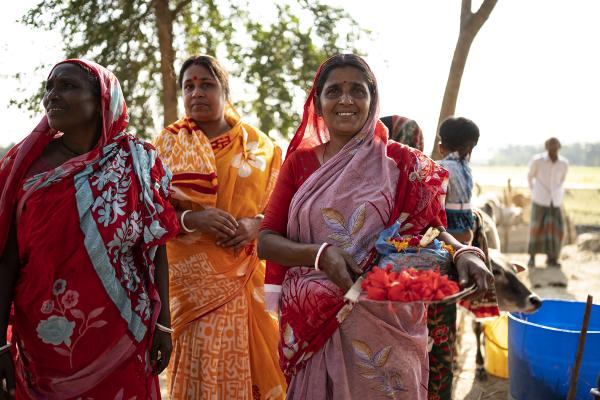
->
[473, 165, 600, 225]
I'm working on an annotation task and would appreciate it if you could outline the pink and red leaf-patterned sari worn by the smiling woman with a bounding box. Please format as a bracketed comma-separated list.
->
[263, 57, 447, 399]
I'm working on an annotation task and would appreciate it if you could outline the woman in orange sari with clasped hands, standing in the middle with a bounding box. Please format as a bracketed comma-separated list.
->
[156, 56, 285, 399]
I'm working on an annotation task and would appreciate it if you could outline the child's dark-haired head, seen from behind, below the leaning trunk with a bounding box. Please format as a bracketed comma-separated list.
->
[439, 117, 479, 158]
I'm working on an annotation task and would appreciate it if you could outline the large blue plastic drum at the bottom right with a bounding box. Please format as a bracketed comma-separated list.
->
[508, 300, 600, 400]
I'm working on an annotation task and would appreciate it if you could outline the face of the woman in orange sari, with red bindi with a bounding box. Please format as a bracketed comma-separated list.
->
[182, 65, 225, 122]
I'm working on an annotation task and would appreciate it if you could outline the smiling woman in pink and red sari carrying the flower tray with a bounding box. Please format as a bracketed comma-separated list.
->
[259, 54, 493, 400]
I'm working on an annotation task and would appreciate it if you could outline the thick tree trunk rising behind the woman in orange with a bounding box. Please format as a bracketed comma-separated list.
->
[154, 0, 179, 126]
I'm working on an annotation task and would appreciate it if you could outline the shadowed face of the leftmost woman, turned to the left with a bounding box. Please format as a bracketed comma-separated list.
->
[42, 63, 100, 132]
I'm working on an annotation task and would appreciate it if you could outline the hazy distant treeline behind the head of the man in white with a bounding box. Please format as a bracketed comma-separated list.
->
[488, 142, 600, 167]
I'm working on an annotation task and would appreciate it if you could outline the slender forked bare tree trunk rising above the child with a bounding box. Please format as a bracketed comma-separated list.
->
[431, 0, 498, 160]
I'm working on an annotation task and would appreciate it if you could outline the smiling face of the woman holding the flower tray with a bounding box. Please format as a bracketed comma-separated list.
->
[317, 67, 371, 140]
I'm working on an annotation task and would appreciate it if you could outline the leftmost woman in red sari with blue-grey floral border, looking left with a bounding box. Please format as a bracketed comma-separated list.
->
[0, 60, 179, 399]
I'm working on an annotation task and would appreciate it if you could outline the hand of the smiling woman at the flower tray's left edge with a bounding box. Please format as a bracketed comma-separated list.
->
[319, 246, 362, 292]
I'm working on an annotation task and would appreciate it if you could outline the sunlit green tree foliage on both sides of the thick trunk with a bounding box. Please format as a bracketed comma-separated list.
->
[12, 0, 367, 137]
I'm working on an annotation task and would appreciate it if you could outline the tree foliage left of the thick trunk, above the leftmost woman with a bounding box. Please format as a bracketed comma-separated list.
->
[13, 0, 160, 137]
